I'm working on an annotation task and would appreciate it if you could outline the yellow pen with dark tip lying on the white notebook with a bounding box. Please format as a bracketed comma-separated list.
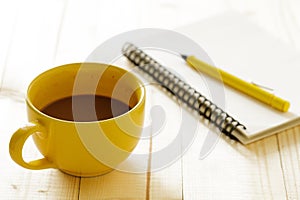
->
[181, 55, 290, 112]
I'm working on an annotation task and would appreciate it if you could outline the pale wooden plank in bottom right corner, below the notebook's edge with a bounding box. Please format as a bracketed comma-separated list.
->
[278, 126, 300, 199]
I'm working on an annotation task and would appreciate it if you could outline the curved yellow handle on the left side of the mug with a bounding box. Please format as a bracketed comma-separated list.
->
[9, 123, 56, 170]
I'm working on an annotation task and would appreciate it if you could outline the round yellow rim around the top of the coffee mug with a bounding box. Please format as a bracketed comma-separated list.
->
[26, 62, 146, 124]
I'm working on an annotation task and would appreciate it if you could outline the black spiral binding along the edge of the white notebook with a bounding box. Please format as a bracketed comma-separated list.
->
[122, 43, 246, 140]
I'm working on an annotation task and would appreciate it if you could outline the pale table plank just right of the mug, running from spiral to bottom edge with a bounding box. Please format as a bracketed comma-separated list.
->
[148, 88, 184, 199]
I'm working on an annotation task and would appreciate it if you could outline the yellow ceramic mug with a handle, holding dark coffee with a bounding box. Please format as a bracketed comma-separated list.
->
[9, 63, 145, 177]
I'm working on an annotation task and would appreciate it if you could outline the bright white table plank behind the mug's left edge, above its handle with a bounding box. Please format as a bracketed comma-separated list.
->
[2, 0, 65, 92]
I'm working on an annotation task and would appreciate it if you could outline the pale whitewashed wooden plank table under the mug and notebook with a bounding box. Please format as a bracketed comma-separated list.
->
[0, 0, 300, 199]
